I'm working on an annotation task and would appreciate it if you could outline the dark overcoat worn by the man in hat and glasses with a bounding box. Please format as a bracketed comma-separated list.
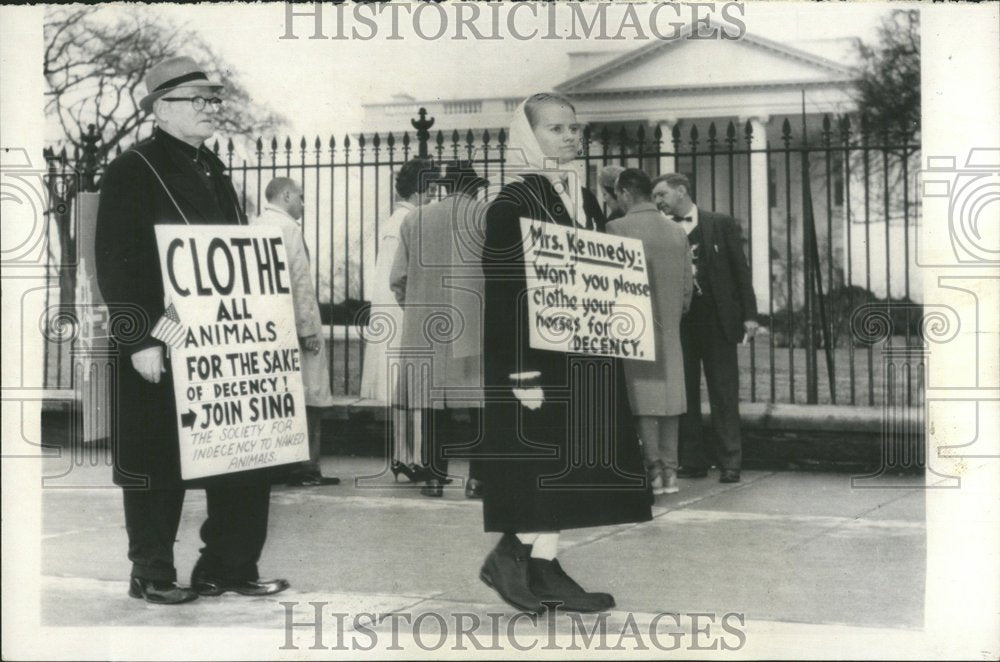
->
[95, 129, 265, 489]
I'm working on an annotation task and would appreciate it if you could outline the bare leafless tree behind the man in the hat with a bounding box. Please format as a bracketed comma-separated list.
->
[43, 5, 285, 312]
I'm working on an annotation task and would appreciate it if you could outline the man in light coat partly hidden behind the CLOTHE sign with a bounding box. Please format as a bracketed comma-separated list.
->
[253, 177, 340, 487]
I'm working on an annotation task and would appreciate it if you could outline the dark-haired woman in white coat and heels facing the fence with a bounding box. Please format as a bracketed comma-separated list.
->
[361, 158, 434, 482]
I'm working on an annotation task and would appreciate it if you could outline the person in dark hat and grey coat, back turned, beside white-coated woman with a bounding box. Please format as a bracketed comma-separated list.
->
[390, 162, 488, 498]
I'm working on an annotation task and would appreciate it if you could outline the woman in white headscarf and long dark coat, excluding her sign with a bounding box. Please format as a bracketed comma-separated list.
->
[480, 94, 652, 612]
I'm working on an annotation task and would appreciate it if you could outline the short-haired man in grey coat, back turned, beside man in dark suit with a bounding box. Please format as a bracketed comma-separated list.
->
[608, 168, 692, 494]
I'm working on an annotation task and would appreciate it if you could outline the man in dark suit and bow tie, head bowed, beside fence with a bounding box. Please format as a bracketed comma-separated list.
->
[653, 173, 757, 483]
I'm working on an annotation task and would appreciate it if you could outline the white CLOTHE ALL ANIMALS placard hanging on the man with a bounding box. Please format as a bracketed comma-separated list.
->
[153, 225, 309, 479]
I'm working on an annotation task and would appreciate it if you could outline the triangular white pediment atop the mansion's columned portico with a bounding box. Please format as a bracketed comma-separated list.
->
[557, 30, 852, 94]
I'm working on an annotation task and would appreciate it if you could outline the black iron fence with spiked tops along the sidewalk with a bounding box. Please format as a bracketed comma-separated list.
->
[45, 109, 922, 405]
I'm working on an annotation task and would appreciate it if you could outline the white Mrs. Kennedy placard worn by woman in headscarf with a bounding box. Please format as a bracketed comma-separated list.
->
[521, 218, 656, 361]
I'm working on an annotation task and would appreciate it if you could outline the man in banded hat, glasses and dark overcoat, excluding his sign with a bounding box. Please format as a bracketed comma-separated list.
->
[95, 57, 288, 604]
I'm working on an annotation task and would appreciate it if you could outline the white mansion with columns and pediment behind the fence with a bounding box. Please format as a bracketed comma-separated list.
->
[364, 29, 919, 311]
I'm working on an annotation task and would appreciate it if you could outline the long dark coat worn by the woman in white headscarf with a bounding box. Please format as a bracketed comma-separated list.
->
[483, 175, 652, 532]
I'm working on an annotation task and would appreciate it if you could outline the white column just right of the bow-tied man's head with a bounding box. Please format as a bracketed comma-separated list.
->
[740, 115, 771, 312]
